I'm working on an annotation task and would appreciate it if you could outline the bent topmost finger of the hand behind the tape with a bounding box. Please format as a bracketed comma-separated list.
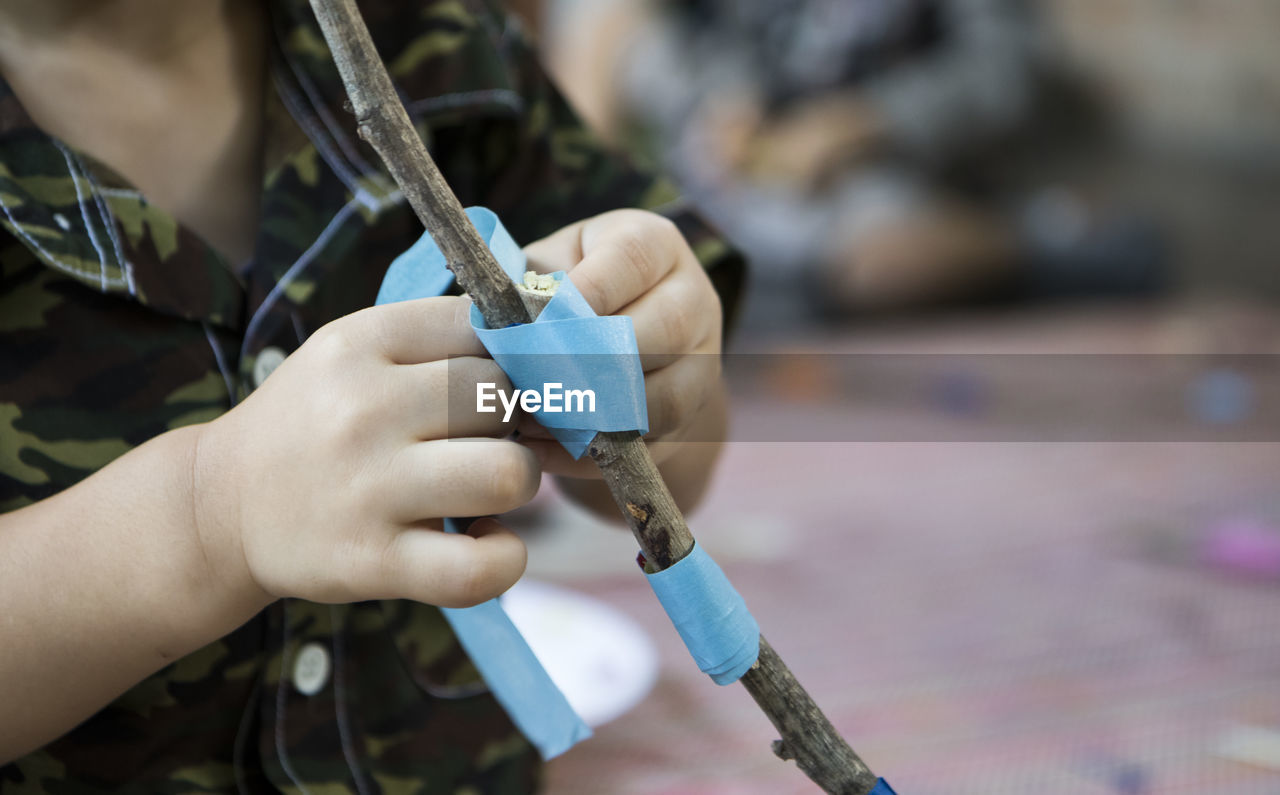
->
[570, 210, 684, 315]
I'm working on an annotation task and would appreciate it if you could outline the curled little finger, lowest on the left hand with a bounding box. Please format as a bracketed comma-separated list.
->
[380, 518, 527, 607]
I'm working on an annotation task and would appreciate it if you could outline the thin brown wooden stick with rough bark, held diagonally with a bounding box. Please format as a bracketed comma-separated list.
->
[311, 0, 877, 795]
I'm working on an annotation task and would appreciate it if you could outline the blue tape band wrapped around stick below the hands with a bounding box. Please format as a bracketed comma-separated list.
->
[645, 544, 760, 685]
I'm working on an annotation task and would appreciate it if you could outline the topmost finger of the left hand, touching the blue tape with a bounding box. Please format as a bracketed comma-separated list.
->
[343, 296, 485, 365]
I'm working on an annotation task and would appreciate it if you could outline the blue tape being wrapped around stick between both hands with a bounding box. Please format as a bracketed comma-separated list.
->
[378, 207, 649, 458]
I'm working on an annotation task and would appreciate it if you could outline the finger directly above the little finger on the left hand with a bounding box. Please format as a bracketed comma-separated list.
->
[381, 438, 541, 524]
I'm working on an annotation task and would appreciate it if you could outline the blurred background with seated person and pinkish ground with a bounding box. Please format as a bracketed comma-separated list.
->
[494, 0, 1280, 795]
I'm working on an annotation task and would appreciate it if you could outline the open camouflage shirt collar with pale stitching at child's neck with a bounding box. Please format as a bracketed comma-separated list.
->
[0, 0, 525, 328]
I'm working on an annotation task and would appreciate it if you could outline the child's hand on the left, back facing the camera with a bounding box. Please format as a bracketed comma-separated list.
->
[195, 297, 540, 607]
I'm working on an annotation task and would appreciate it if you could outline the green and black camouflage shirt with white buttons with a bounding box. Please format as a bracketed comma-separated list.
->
[0, 0, 741, 795]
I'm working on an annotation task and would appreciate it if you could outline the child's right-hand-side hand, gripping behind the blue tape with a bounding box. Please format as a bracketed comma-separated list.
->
[520, 210, 721, 478]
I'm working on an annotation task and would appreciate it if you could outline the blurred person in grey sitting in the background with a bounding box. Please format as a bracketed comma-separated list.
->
[547, 0, 1165, 314]
